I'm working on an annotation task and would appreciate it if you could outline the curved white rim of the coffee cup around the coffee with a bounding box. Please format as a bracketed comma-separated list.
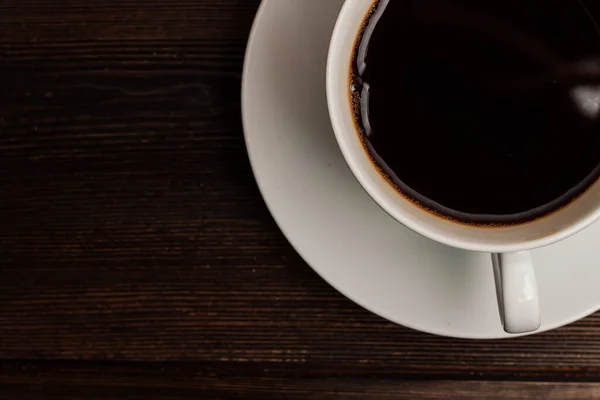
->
[326, 0, 600, 253]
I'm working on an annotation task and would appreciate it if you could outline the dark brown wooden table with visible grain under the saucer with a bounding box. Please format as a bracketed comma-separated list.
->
[0, 0, 600, 400]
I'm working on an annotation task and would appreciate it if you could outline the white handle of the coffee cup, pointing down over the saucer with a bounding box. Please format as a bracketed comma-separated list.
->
[492, 251, 541, 333]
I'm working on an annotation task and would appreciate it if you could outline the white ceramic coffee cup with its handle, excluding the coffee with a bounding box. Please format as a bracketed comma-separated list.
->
[327, 0, 600, 333]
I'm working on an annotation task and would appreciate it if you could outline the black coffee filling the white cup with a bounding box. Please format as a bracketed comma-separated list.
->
[350, 0, 600, 224]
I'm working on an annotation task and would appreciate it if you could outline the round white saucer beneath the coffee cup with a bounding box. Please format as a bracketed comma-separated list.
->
[242, 0, 600, 338]
